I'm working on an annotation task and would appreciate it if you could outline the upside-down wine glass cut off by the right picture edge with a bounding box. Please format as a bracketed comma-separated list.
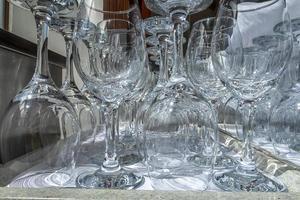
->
[270, 18, 300, 156]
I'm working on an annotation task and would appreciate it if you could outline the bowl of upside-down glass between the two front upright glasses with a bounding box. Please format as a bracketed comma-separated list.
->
[138, 67, 216, 190]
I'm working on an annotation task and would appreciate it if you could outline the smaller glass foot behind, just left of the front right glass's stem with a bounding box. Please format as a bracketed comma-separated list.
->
[188, 154, 236, 170]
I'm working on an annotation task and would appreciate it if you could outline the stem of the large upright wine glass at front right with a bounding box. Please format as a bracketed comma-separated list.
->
[238, 101, 256, 172]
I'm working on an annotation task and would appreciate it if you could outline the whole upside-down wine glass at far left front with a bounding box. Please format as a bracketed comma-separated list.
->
[0, 0, 80, 187]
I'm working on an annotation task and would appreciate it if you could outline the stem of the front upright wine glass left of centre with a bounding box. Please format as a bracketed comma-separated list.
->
[102, 106, 120, 172]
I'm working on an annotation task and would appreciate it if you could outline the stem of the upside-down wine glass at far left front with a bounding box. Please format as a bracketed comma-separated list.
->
[34, 11, 51, 79]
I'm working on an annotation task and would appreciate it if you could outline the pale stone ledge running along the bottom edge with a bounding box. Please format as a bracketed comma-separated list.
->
[0, 187, 300, 200]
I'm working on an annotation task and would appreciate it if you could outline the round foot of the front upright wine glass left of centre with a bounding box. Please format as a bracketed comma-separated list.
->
[76, 169, 144, 189]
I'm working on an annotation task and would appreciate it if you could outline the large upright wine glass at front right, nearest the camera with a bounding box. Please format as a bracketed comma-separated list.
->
[212, 0, 292, 192]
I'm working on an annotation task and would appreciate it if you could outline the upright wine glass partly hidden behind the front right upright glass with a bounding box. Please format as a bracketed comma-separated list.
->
[186, 17, 235, 170]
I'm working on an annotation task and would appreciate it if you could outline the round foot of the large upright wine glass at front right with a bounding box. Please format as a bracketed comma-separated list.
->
[213, 170, 287, 192]
